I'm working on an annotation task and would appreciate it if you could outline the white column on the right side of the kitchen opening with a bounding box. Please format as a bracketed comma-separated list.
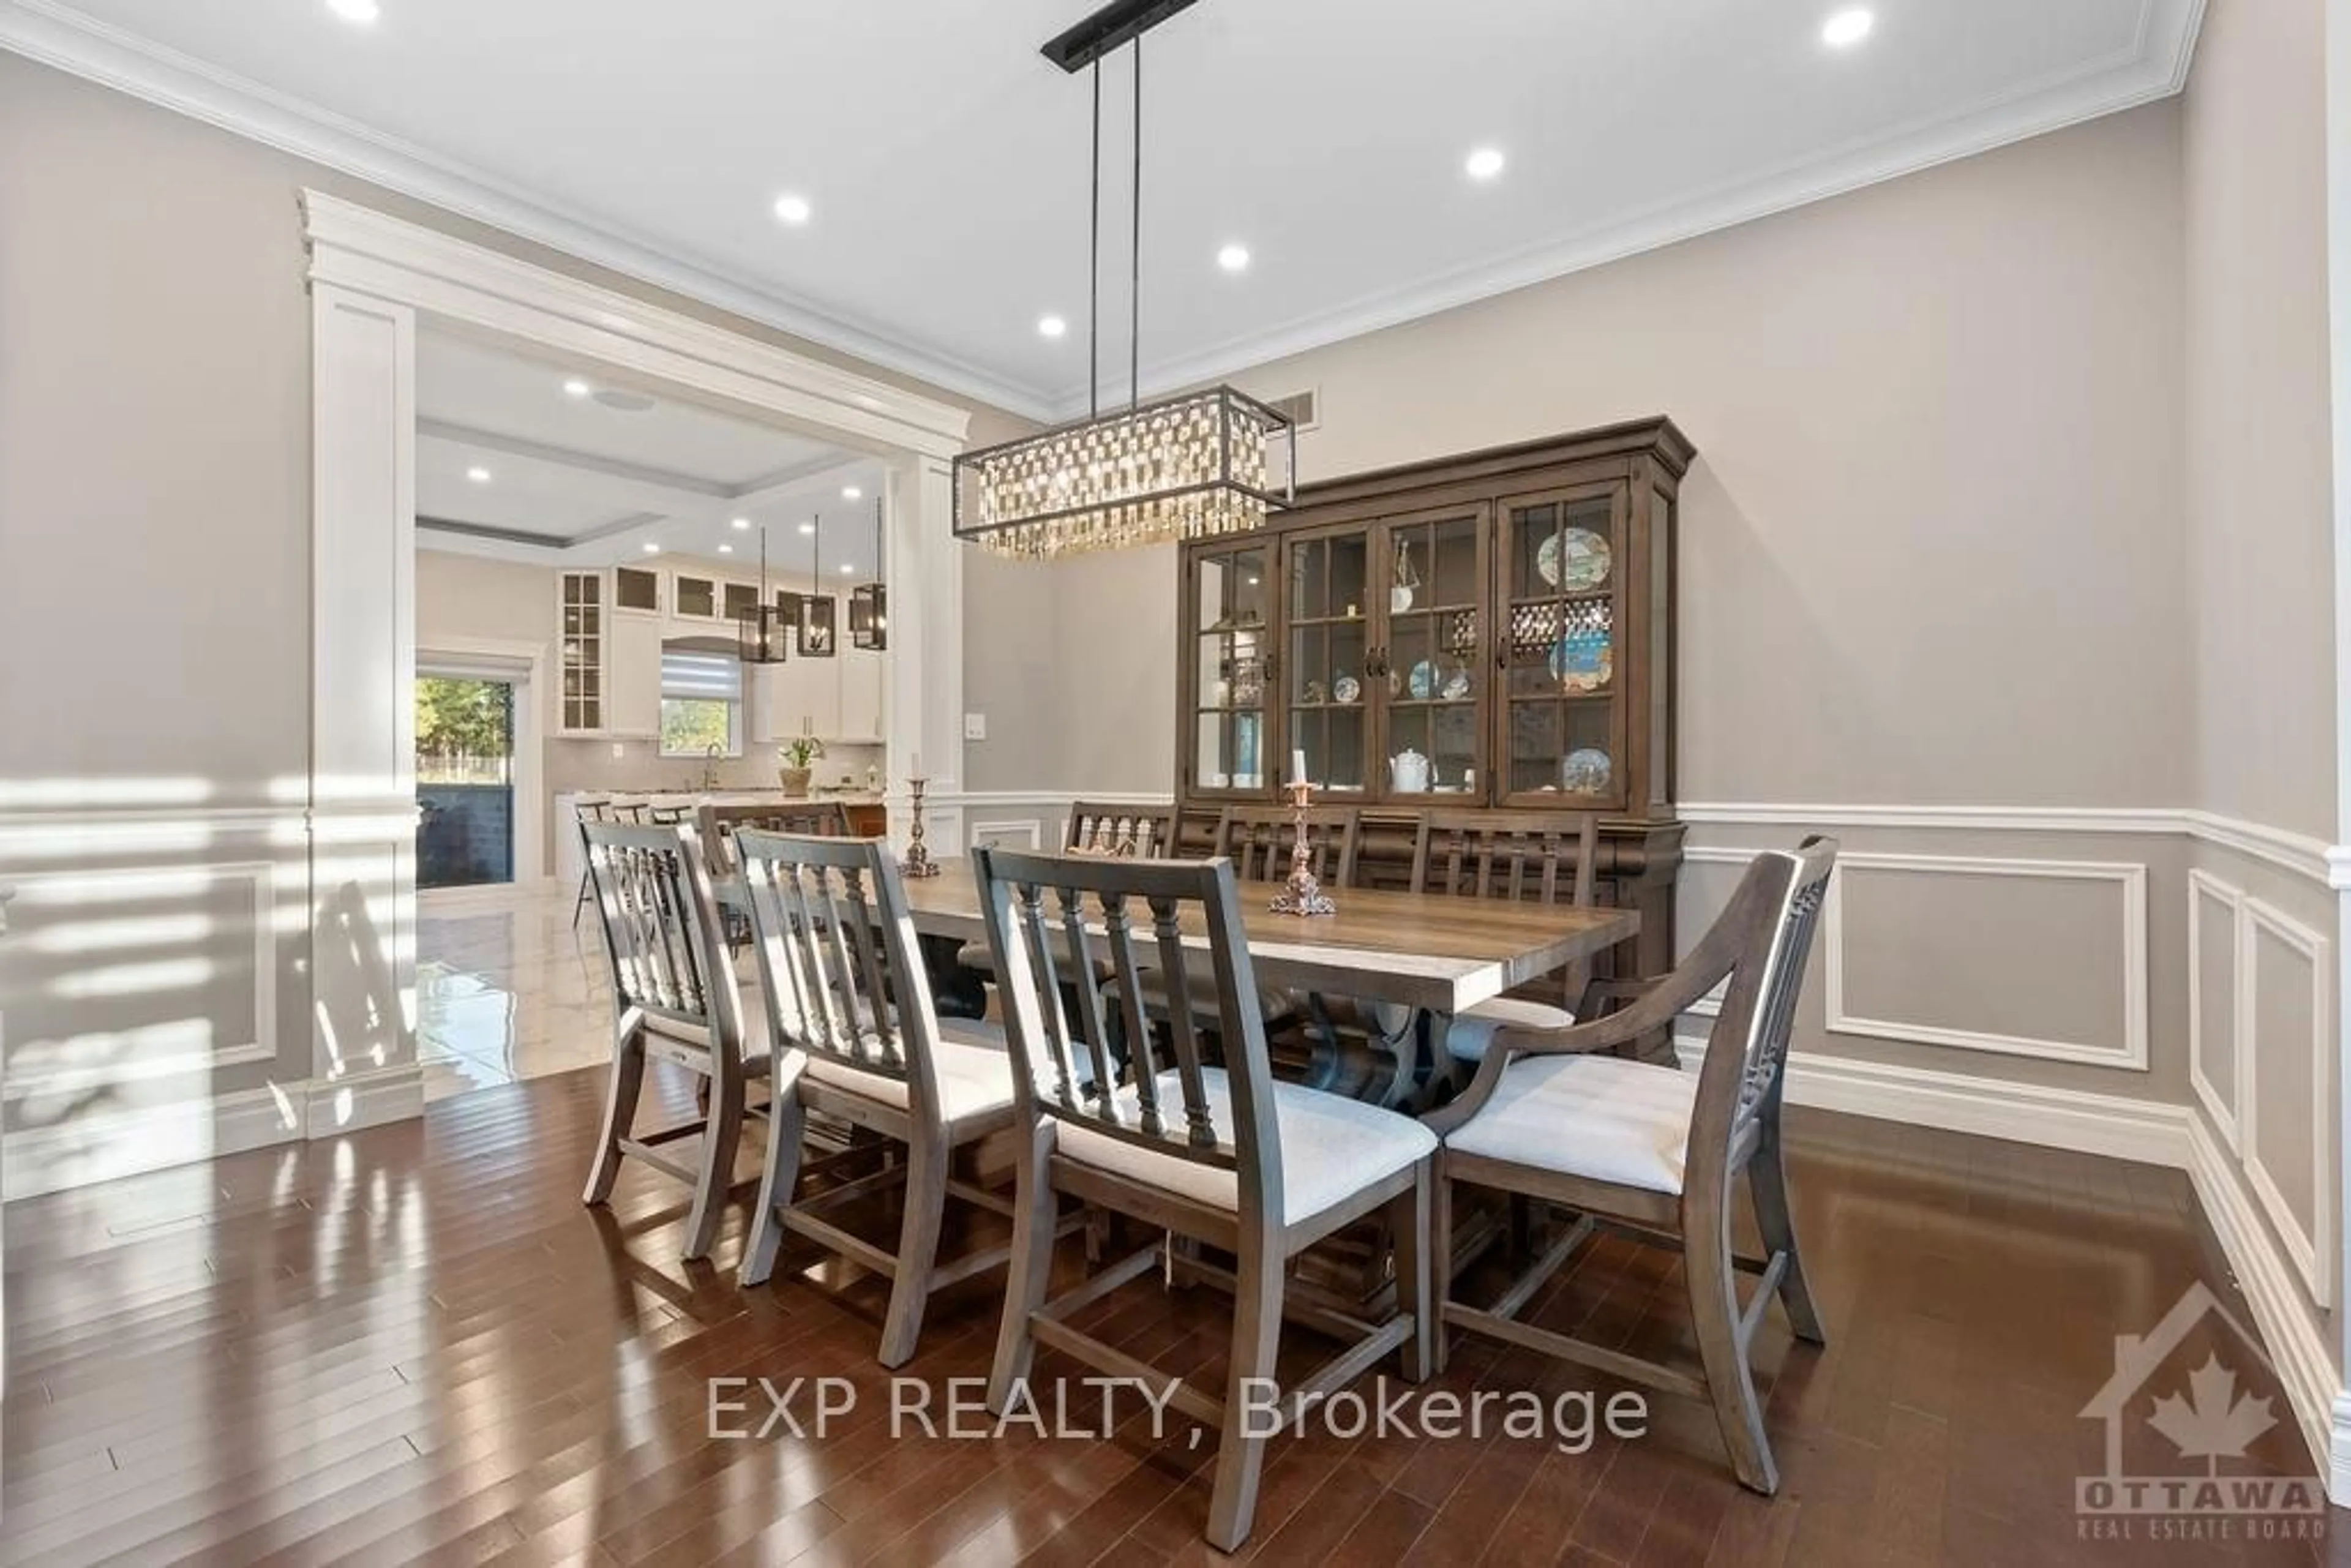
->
[887, 456, 969, 860]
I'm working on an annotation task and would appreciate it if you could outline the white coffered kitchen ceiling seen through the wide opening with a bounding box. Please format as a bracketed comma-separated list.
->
[416, 329, 884, 576]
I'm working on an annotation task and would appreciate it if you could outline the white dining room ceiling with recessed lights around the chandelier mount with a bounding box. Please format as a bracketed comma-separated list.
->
[0, 0, 2203, 411]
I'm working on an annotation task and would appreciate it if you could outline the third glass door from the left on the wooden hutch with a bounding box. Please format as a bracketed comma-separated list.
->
[1373, 506, 1491, 804]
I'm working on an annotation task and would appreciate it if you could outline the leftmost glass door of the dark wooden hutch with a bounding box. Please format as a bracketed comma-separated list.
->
[1185, 543, 1274, 795]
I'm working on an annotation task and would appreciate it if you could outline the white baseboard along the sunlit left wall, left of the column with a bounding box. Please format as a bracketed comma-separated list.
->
[0, 1062, 426, 1199]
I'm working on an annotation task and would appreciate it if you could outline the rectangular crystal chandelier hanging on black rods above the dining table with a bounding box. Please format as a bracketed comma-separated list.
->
[954, 0, 1298, 560]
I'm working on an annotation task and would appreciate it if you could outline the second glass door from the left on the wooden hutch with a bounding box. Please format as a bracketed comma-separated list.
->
[1274, 524, 1385, 799]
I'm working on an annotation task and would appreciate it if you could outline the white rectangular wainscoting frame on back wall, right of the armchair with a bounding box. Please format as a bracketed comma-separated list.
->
[1822, 853, 2147, 1072]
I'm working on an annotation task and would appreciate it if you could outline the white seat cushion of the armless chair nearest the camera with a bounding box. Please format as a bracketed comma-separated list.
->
[1060, 1067, 1436, 1225]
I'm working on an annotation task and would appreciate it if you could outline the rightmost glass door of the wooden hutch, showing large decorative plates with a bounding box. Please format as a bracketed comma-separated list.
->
[1493, 484, 1627, 811]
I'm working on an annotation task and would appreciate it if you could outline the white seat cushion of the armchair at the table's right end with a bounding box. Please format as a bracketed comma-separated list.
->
[1446, 1056, 1697, 1195]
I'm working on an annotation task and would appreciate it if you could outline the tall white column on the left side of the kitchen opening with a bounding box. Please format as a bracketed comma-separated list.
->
[306, 282, 423, 1138]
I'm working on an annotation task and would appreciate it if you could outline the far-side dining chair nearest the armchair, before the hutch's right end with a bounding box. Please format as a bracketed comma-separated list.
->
[1411, 809, 1601, 1062]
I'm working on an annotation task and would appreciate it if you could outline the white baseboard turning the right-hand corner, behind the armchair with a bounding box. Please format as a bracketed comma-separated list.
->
[1674, 1034, 2351, 1507]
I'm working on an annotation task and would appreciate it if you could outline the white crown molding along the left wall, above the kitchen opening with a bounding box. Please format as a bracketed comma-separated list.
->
[0, 0, 1056, 418]
